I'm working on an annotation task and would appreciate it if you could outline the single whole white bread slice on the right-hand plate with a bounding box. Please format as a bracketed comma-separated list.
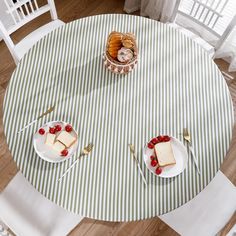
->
[155, 142, 176, 167]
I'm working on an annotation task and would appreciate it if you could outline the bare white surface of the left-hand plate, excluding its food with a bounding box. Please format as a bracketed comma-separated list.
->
[33, 121, 78, 163]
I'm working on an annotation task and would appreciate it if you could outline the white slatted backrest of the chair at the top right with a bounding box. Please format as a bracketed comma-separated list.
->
[171, 0, 236, 49]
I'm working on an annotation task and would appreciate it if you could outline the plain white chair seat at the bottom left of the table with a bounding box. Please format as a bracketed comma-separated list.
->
[0, 172, 83, 236]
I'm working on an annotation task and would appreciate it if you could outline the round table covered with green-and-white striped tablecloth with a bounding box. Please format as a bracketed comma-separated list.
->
[4, 15, 233, 221]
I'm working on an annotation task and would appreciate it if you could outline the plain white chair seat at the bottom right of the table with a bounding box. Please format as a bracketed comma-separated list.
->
[160, 171, 236, 236]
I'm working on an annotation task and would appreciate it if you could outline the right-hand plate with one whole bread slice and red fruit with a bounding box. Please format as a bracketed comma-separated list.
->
[144, 135, 188, 178]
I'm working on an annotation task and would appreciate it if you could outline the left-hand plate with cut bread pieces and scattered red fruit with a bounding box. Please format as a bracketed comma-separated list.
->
[33, 121, 78, 162]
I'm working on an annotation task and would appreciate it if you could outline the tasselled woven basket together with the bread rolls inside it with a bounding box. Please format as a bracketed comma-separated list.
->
[103, 31, 138, 74]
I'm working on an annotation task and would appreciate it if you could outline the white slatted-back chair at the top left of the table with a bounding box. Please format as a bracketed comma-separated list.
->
[0, 0, 65, 64]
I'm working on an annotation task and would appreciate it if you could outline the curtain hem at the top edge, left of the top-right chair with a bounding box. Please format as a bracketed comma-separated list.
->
[124, 0, 176, 22]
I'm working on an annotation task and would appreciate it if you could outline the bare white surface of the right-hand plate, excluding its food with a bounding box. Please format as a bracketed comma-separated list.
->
[144, 137, 188, 178]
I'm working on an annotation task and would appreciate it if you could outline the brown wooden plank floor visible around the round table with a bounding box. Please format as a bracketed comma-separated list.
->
[0, 0, 236, 236]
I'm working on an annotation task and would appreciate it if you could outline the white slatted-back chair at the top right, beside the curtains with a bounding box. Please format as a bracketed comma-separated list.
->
[170, 0, 236, 57]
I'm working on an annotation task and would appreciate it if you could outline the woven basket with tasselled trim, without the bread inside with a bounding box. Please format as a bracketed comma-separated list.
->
[103, 31, 138, 74]
